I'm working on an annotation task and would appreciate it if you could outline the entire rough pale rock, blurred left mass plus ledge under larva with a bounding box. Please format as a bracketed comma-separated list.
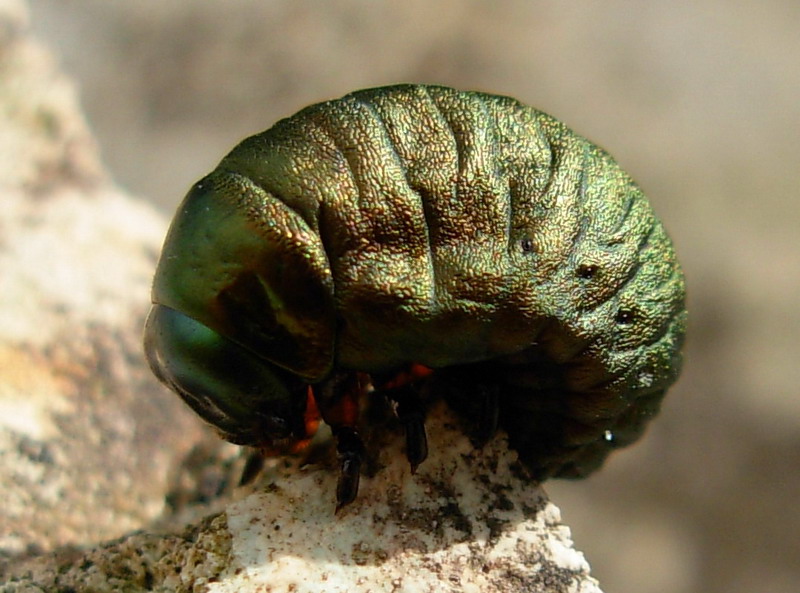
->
[0, 0, 598, 593]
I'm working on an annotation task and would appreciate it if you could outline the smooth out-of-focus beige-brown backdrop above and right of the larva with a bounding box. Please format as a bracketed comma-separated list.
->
[30, 0, 800, 593]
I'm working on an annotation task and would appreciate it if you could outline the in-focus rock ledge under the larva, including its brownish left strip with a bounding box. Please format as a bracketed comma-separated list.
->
[0, 405, 600, 593]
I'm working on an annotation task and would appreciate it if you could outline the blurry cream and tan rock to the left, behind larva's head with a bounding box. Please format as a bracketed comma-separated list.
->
[0, 0, 231, 560]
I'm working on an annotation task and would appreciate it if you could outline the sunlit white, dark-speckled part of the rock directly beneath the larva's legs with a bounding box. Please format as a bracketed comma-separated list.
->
[216, 406, 599, 593]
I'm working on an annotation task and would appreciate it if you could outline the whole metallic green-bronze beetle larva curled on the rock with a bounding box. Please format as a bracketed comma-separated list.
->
[145, 85, 686, 506]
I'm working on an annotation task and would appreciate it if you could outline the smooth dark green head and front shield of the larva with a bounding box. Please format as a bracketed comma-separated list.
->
[145, 173, 332, 444]
